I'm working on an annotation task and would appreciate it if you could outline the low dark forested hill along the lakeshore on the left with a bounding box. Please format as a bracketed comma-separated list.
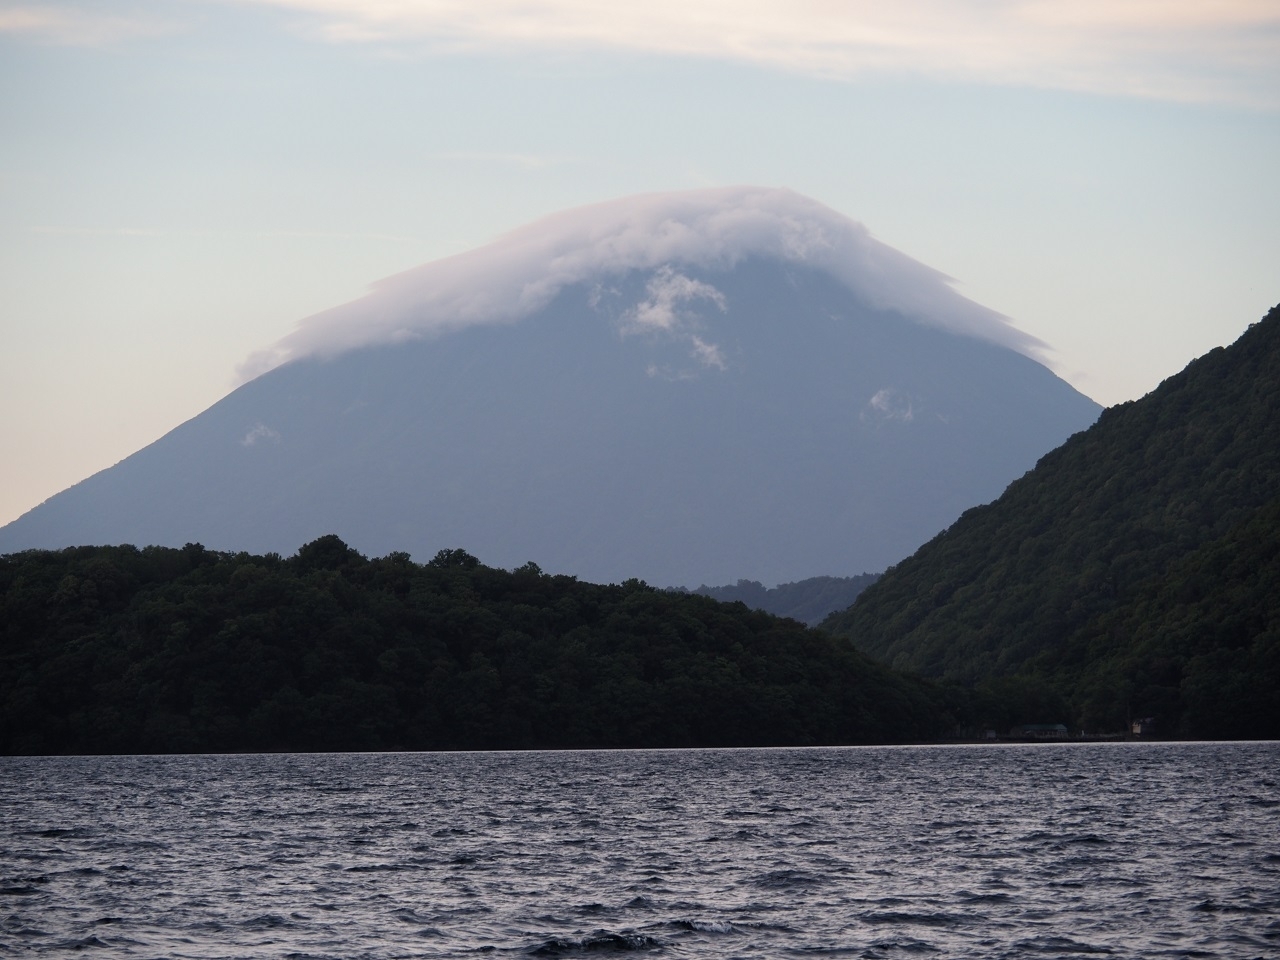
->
[0, 536, 954, 754]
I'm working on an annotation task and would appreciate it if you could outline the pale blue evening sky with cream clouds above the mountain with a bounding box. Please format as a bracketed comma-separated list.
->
[0, 0, 1280, 524]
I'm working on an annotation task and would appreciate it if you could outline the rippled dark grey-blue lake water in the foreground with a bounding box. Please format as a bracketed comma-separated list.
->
[0, 742, 1280, 959]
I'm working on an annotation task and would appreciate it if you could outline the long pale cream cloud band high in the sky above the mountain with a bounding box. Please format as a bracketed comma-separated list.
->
[234, 0, 1280, 108]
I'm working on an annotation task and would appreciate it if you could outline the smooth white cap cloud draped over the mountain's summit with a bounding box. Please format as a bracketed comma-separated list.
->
[239, 187, 1044, 379]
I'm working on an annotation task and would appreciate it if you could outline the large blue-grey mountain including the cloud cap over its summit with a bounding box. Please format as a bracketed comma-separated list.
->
[0, 187, 1100, 585]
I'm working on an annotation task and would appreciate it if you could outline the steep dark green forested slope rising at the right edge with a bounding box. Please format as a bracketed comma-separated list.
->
[823, 307, 1280, 737]
